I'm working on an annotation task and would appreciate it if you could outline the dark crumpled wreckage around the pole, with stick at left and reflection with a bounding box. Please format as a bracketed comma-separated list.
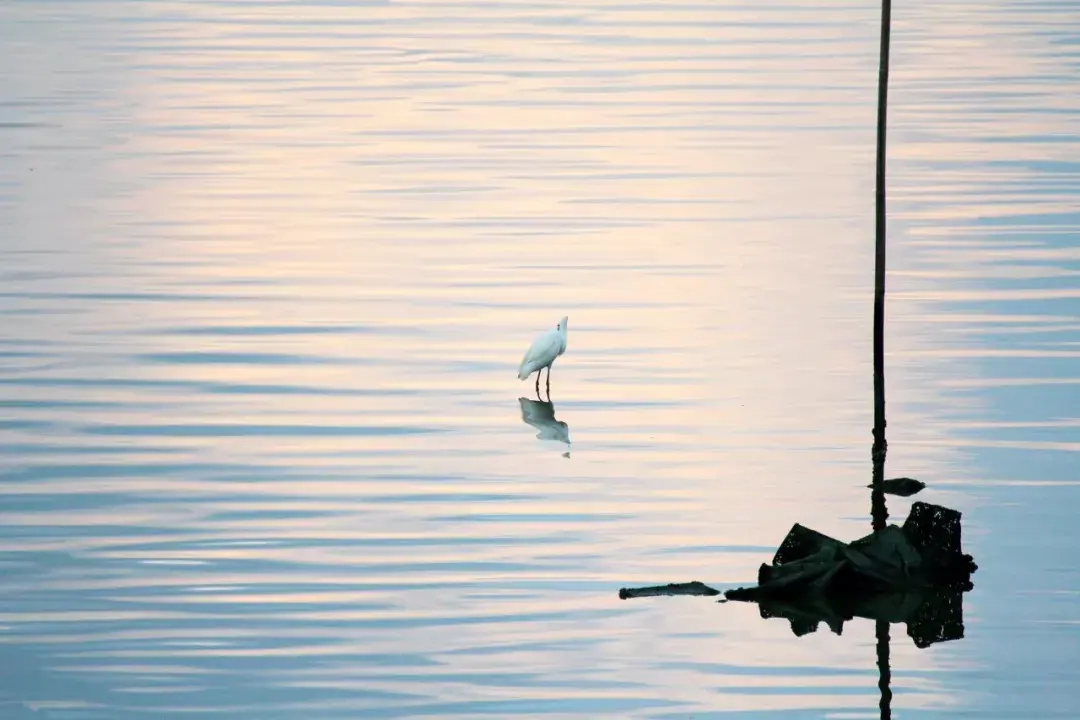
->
[619, 502, 977, 648]
